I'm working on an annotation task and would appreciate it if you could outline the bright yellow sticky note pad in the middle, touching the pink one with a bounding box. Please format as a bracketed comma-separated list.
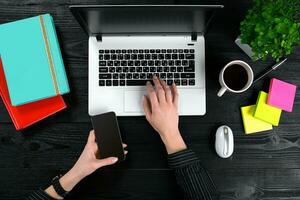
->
[254, 91, 281, 126]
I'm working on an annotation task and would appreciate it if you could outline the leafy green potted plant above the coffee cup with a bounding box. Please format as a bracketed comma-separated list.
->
[236, 0, 300, 62]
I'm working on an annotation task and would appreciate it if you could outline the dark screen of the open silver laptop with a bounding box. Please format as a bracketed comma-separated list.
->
[70, 5, 223, 35]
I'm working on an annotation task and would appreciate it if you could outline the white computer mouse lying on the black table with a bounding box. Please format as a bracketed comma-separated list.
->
[215, 125, 234, 158]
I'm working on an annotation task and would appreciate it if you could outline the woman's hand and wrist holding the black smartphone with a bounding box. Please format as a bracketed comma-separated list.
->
[46, 130, 128, 199]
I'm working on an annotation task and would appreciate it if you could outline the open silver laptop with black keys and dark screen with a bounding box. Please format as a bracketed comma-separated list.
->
[70, 5, 223, 116]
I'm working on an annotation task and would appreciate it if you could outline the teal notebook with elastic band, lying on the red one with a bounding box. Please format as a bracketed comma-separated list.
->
[0, 14, 70, 106]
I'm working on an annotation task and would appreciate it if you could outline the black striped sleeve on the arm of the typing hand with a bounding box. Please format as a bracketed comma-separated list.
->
[168, 149, 218, 200]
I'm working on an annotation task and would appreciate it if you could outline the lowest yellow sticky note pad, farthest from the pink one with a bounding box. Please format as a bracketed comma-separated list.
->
[241, 105, 273, 134]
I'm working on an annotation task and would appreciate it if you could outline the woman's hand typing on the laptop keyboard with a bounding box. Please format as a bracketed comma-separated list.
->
[143, 76, 186, 154]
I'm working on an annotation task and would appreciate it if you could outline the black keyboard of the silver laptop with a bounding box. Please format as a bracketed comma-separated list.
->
[99, 49, 195, 86]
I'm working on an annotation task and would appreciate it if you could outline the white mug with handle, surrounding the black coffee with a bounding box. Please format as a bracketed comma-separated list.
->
[218, 60, 254, 97]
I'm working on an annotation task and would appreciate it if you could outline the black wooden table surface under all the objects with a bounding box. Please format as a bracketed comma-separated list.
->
[0, 0, 300, 200]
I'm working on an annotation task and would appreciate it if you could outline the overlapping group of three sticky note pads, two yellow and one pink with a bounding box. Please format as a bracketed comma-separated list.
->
[241, 78, 296, 134]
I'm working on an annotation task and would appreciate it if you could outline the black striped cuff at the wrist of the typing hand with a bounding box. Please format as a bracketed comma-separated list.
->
[168, 149, 199, 169]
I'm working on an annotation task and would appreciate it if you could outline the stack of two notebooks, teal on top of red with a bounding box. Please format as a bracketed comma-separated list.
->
[0, 14, 69, 130]
